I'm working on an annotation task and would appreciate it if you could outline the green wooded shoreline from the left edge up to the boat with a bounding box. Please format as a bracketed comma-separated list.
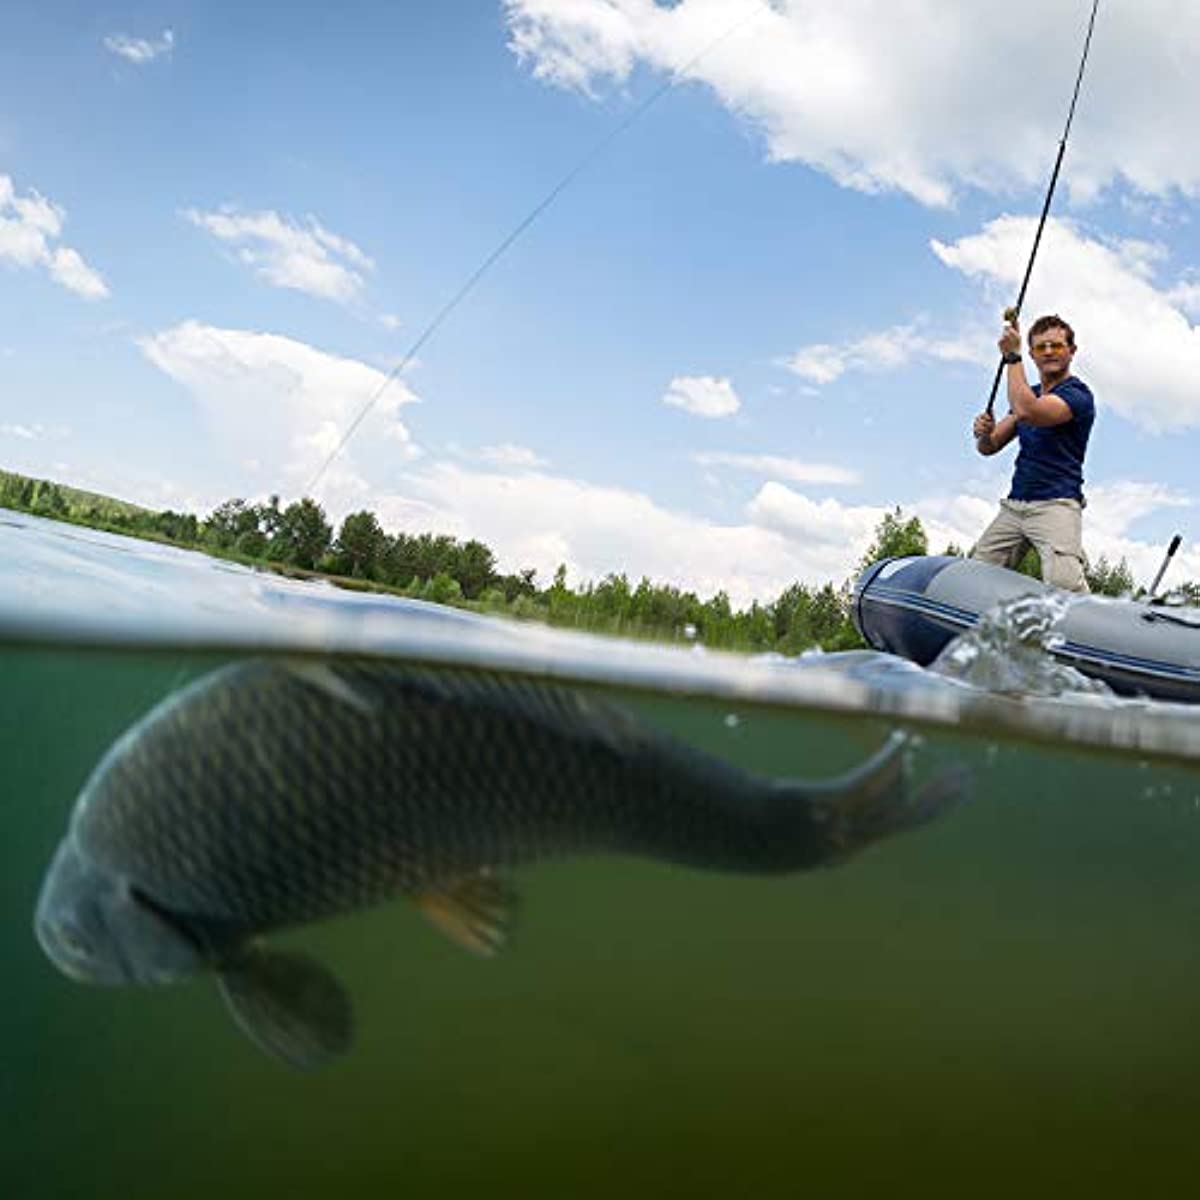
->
[0, 470, 883, 654]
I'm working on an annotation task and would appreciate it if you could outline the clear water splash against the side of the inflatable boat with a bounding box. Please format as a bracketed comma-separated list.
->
[929, 592, 1112, 696]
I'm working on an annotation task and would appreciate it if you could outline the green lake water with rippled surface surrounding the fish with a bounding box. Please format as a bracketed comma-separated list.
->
[7, 514, 1200, 1200]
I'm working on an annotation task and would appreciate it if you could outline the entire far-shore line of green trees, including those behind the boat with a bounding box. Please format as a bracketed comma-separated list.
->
[0, 472, 1161, 654]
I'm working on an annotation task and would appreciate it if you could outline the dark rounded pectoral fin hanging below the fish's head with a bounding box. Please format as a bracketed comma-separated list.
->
[217, 947, 354, 1070]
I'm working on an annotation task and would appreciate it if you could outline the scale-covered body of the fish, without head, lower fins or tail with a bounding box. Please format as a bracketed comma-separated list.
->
[78, 664, 897, 902]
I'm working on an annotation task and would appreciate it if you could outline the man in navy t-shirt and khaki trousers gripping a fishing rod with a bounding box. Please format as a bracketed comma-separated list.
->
[971, 313, 1096, 592]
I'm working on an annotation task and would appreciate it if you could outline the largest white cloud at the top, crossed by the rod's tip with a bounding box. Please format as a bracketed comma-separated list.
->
[504, 0, 1200, 205]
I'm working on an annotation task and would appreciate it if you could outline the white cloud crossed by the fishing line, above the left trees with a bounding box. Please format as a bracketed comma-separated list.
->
[138, 320, 420, 503]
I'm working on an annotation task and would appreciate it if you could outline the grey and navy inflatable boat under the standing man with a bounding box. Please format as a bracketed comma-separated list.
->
[852, 556, 1200, 703]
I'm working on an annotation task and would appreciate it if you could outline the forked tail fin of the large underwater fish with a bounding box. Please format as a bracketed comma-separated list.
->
[792, 732, 971, 863]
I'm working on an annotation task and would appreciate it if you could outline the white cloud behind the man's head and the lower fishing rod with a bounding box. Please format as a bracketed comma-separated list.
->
[932, 216, 1200, 432]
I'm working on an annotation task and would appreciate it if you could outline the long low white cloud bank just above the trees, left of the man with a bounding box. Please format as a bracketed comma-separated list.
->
[372, 462, 996, 606]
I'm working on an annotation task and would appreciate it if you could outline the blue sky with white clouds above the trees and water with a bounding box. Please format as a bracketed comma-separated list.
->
[0, 0, 1200, 606]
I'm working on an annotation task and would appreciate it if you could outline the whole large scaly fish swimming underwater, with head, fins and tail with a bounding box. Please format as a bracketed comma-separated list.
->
[35, 661, 960, 1067]
